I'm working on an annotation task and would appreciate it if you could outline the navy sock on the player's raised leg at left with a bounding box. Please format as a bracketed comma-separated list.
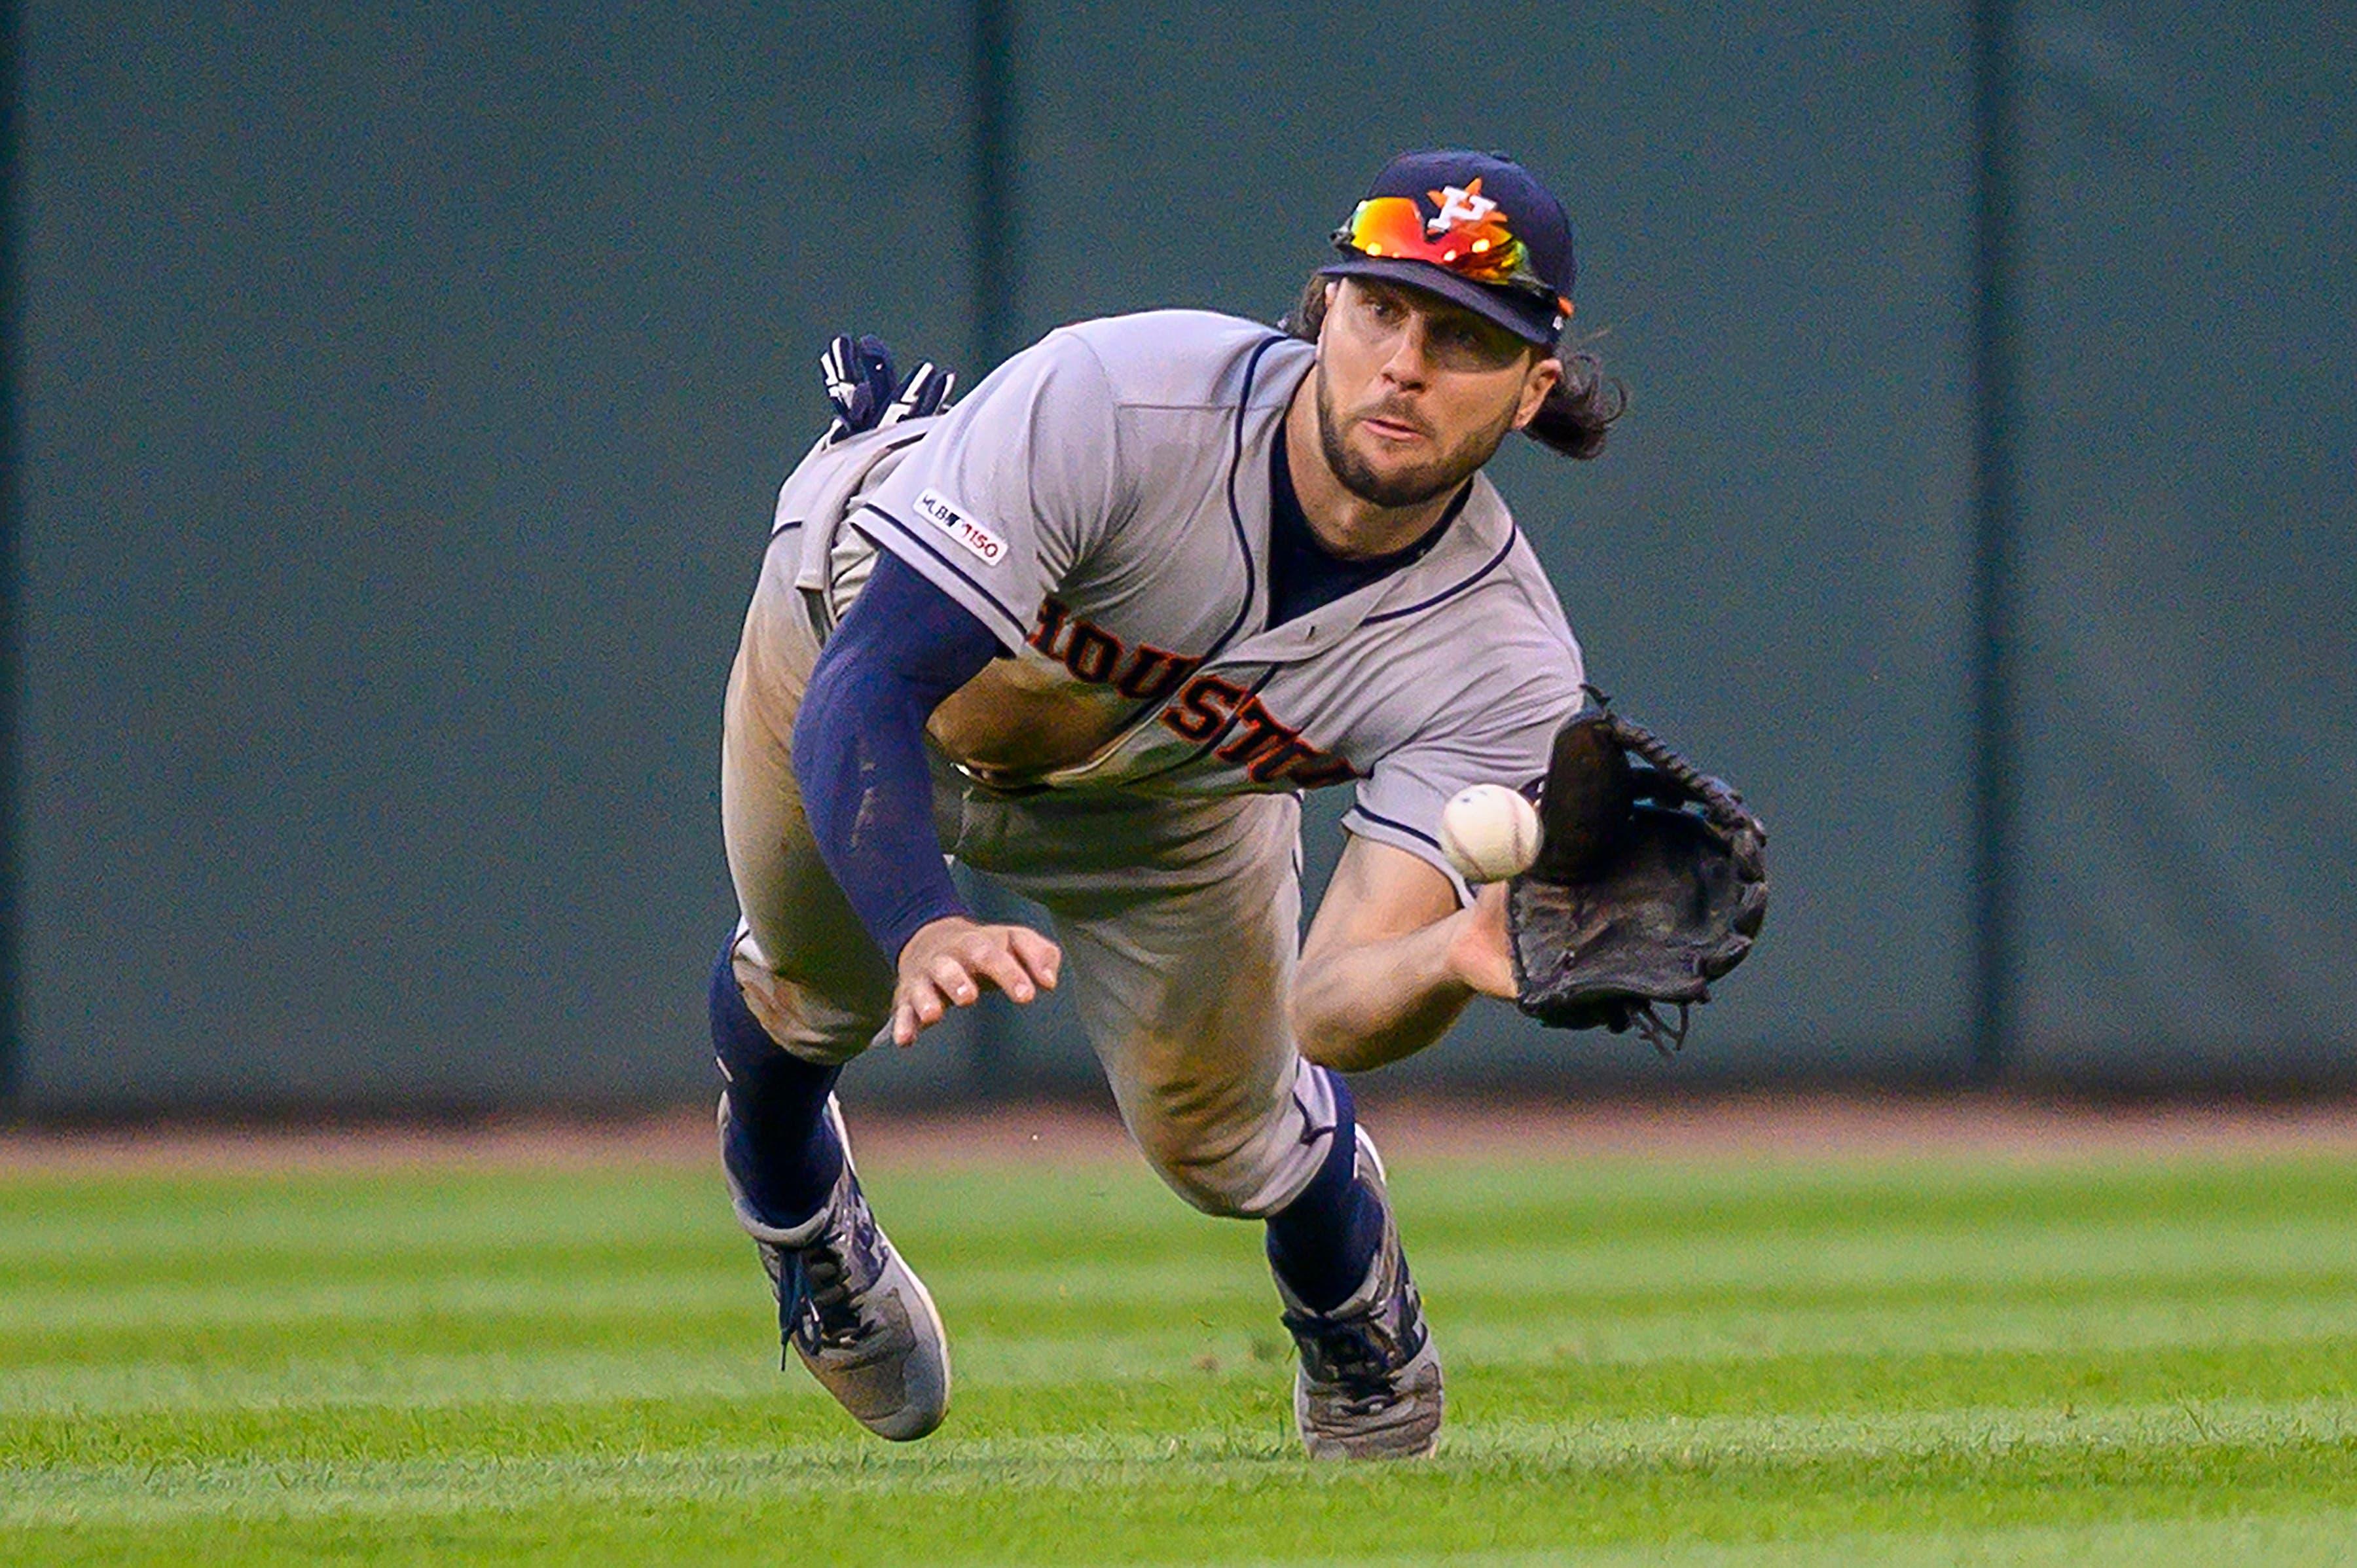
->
[712, 941, 844, 1231]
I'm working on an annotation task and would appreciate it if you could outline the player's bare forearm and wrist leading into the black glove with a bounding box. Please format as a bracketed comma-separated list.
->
[1294, 837, 1513, 1070]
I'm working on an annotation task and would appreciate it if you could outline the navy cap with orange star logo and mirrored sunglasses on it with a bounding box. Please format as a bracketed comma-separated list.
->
[1317, 149, 1579, 349]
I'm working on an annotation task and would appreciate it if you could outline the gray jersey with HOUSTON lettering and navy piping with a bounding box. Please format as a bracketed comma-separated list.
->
[778, 311, 1582, 898]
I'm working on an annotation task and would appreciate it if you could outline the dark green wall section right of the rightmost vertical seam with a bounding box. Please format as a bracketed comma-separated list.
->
[2022, 0, 2357, 1078]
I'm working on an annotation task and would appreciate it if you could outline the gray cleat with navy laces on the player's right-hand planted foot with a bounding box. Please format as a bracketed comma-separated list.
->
[1277, 1132, 1442, 1459]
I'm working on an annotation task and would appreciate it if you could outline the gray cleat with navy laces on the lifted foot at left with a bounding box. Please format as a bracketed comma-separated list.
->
[722, 1097, 950, 1443]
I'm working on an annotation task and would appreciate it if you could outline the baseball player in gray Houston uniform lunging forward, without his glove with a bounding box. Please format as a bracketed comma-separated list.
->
[712, 151, 1619, 1457]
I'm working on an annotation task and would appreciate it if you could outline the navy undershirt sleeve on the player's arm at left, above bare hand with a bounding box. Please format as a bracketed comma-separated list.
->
[794, 549, 999, 962]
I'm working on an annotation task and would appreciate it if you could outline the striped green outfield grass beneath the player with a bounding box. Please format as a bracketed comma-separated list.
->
[0, 1131, 2357, 1568]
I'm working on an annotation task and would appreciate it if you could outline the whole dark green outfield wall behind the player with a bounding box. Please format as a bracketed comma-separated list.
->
[7, 0, 2357, 1116]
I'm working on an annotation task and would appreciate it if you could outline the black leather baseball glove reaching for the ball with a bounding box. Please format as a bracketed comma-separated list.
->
[1506, 689, 1768, 1056]
